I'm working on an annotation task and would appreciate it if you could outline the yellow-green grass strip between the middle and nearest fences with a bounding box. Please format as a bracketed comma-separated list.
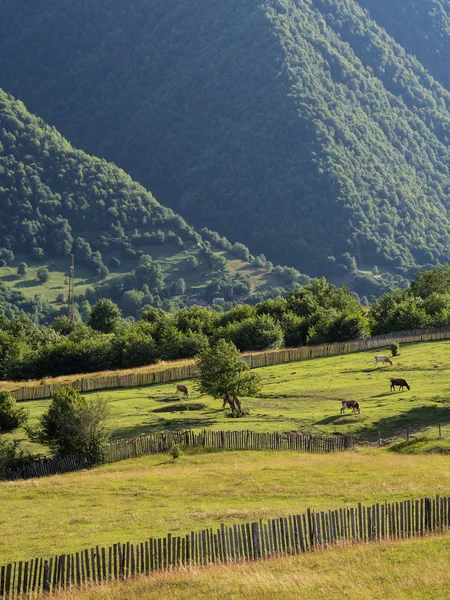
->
[0, 448, 450, 564]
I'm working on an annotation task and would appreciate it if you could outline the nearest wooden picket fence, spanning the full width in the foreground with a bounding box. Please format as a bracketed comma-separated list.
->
[0, 496, 450, 600]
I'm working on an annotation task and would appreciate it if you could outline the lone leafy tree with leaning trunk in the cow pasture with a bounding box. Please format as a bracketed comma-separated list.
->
[196, 339, 262, 417]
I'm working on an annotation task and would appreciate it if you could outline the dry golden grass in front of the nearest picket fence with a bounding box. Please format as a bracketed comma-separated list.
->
[57, 535, 450, 600]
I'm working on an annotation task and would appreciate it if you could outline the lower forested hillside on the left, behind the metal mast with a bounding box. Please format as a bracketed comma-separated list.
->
[0, 90, 300, 317]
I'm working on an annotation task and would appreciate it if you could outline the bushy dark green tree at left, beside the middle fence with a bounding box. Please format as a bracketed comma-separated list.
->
[26, 385, 108, 462]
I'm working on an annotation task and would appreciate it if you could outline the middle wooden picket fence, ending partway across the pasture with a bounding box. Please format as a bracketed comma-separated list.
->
[3, 430, 355, 481]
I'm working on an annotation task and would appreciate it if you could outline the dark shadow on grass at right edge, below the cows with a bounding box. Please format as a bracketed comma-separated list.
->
[358, 406, 450, 441]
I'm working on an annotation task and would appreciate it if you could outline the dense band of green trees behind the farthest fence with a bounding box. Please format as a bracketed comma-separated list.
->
[0, 266, 450, 379]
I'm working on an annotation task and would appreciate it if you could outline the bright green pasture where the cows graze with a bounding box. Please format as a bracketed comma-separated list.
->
[5, 341, 450, 451]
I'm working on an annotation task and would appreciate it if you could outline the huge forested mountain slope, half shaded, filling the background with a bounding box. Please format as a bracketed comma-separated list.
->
[0, 0, 450, 275]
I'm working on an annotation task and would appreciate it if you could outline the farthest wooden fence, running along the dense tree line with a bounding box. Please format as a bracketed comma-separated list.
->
[12, 327, 450, 401]
